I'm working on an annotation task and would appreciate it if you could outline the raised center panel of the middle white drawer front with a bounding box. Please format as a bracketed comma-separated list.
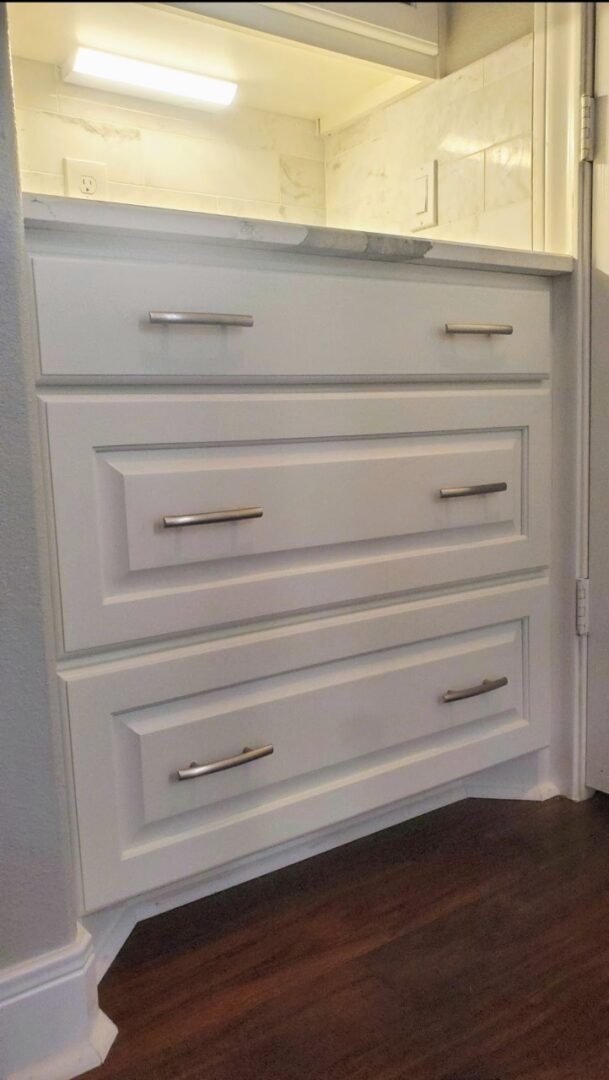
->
[121, 431, 523, 570]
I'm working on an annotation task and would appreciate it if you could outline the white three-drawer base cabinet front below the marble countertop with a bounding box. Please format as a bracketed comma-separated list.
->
[27, 208, 553, 912]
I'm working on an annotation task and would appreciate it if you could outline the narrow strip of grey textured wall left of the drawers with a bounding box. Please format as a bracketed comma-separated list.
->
[0, 4, 76, 966]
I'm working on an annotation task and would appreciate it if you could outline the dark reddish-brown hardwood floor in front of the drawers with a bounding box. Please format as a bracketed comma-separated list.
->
[89, 796, 609, 1080]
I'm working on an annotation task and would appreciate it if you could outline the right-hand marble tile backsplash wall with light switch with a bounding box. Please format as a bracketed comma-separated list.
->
[325, 35, 533, 248]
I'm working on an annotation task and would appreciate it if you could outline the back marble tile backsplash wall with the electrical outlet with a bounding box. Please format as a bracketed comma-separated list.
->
[13, 57, 325, 225]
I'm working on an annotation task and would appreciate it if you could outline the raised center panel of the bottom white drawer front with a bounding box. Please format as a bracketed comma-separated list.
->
[138, 622, 524, 824]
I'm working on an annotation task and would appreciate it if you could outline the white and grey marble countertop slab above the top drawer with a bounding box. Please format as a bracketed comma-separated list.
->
[23, 194, 574, 275]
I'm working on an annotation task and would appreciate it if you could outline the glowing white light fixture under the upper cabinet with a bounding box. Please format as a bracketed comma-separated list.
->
[63, 45, 236, 109]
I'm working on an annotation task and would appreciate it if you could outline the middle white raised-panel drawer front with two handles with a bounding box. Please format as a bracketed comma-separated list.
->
[43, 389, 551, 651]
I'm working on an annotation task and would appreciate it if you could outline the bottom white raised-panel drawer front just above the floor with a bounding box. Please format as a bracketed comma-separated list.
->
[62, 579, 550, 909]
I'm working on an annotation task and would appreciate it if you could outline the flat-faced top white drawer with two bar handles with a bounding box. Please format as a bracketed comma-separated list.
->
[32, 255, 550, 382]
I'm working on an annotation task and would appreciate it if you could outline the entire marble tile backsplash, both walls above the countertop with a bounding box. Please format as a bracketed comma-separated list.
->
[14, 36, 533, 249]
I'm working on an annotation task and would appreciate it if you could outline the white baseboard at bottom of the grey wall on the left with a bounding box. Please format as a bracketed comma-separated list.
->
[0, 927, 117, 1080]
